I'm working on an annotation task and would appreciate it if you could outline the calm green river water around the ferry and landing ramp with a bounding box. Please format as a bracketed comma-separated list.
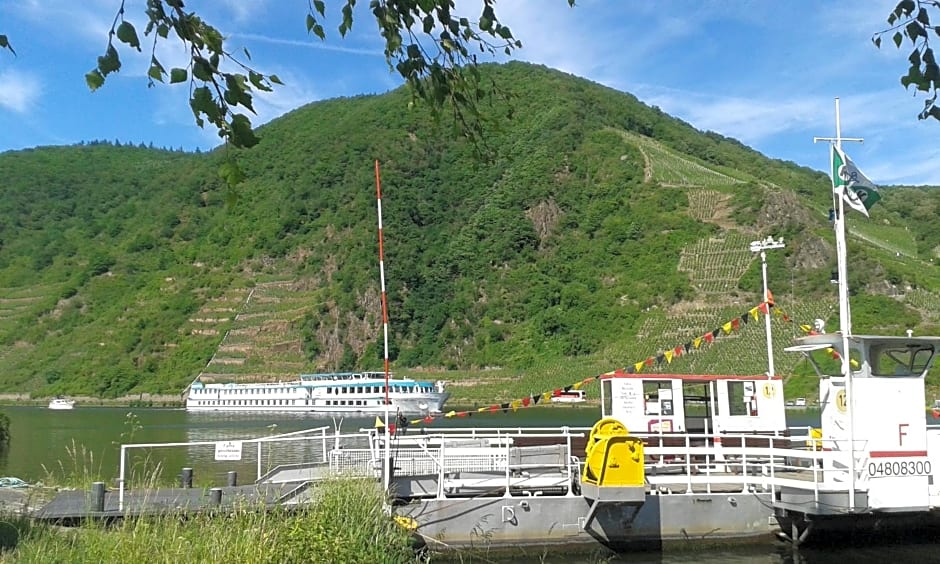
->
[0, 406, 940, 564]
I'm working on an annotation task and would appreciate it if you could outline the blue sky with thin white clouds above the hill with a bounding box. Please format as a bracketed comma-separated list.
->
[0, 0, 940, 185]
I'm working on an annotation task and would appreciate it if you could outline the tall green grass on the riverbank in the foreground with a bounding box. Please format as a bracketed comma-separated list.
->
[0, 478, 417, 564]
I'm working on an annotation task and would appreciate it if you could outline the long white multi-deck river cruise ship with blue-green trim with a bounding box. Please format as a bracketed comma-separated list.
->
[186, 372, 450, 415]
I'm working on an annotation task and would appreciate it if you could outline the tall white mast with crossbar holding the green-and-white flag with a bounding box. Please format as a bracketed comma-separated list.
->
[813, 98, 864, 511]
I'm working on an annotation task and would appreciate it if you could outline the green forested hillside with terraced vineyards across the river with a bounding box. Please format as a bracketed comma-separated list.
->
[0, 63, 940, 396]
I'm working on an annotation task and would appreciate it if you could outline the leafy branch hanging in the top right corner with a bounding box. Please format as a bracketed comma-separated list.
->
[872, 0, 940, 120]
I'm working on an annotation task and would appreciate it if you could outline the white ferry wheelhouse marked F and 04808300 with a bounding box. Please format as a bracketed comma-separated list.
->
[787, 333, 940, 511]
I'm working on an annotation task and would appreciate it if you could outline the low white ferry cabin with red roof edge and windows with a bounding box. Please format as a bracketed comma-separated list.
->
[600, 370, 787, 434]
